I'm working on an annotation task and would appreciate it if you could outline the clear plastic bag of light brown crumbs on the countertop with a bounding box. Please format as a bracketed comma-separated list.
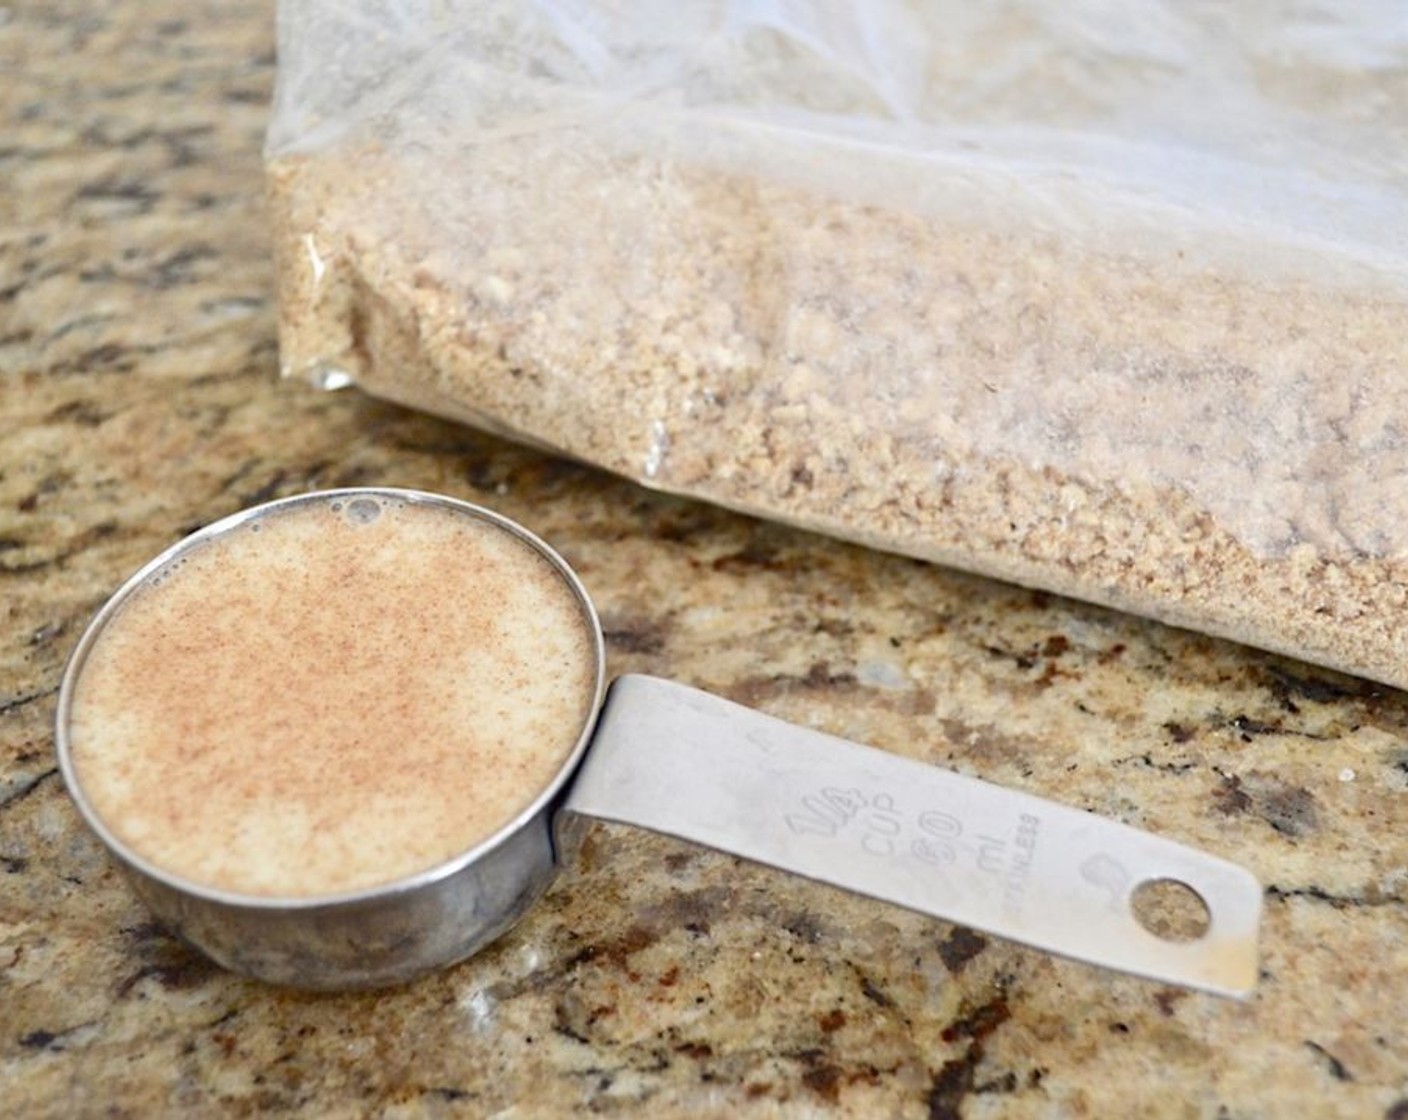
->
[269, 0, 1408, 686]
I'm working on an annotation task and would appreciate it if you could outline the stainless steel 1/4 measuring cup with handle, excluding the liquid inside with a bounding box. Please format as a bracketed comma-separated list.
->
[55, 489, 1262, 996]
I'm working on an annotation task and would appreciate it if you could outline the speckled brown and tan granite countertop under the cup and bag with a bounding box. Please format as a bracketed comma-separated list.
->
[0, 0, 1408, 1120]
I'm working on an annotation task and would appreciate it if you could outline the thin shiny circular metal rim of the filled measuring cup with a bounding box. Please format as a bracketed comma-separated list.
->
[54, 486, 605, 910]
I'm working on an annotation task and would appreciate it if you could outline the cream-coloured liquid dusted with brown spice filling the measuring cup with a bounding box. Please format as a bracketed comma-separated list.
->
[69, 494, 597, 897]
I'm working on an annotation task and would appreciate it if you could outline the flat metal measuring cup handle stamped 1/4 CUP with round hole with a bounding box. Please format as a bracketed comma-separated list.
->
[563, 676, 1262, 996]
